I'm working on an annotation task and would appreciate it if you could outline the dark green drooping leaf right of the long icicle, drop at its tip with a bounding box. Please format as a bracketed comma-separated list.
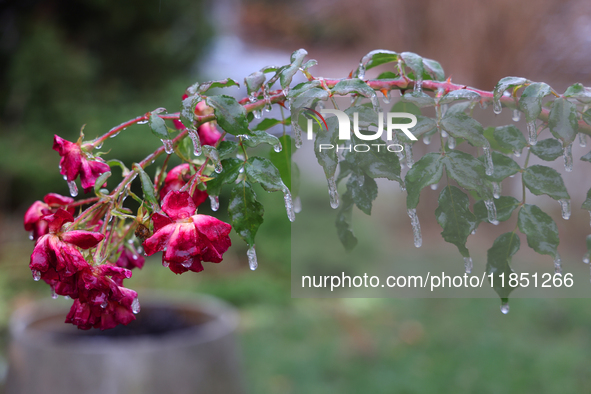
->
[435, 185, 477, 257]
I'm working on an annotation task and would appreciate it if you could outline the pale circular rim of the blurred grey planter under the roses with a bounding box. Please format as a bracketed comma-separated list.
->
[9, 291, 239, 354]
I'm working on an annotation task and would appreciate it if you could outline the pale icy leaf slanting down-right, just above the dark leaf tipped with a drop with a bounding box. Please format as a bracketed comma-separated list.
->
[442, 150, 492, 200]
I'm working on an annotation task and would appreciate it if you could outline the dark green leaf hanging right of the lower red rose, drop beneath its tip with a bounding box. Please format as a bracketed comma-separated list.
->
[228, 182, 265, 246]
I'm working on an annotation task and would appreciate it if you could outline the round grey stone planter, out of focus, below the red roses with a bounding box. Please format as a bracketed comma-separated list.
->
[6, 296, 244, 394]
